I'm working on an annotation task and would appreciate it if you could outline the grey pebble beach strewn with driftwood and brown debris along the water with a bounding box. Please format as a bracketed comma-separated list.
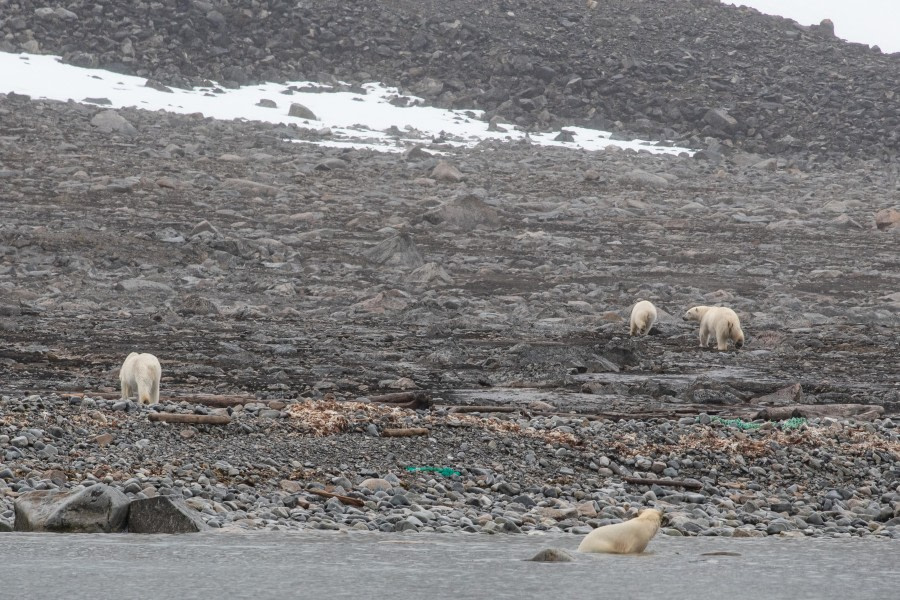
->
[0, 395, 900, 538]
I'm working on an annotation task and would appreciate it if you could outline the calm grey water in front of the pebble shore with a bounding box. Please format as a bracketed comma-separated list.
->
[0, 532, 900, 600]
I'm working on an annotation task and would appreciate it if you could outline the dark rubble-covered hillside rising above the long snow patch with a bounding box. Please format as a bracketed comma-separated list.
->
[0, 0, 900, 162]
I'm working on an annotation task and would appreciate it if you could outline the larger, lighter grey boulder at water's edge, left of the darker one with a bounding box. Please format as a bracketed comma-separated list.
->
[13, 484, 129, 533]
